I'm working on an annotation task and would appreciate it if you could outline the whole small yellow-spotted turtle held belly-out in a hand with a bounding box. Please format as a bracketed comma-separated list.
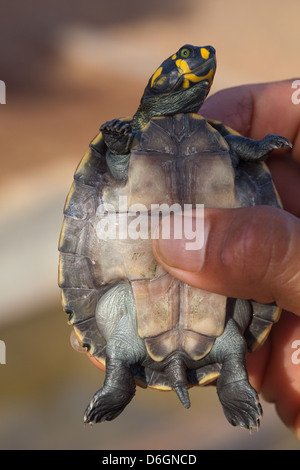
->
[59, 44, 291, 429]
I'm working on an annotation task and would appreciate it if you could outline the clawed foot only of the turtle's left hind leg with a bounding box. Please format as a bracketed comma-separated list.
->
[84, 387, 134, 424]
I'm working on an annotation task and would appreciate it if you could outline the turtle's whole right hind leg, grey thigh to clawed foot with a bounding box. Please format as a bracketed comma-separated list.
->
[208, 319, 262, 430]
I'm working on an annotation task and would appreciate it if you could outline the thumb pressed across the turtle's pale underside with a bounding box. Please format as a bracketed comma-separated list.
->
[153, 206, 300, 315]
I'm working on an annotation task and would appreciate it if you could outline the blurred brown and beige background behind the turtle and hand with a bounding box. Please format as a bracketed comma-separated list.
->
[0, 0, 300, 450]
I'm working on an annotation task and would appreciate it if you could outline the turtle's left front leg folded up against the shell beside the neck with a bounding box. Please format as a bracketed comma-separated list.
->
[100, 119, 133, 183]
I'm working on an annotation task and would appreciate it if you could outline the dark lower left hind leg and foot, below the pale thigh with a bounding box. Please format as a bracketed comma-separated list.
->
[84, 358, 135, 424]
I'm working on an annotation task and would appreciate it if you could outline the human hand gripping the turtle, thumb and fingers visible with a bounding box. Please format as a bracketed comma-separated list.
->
[153, 80, 300, 440]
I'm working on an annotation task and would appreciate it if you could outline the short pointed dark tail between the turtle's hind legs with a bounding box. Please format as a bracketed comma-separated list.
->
[165, 354, 191, 408]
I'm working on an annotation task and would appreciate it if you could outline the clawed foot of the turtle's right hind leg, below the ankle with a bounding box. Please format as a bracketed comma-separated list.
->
[217, 379, 262, 431]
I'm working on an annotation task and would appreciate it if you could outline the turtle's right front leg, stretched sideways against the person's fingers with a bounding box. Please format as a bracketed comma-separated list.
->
[225, 134, 292, 161]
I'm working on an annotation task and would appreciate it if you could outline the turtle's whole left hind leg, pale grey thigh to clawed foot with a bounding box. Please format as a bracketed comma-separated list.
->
[84, 282, 145, 423]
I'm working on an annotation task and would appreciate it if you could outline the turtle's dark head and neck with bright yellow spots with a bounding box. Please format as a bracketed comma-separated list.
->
[134, 44, 216, 127]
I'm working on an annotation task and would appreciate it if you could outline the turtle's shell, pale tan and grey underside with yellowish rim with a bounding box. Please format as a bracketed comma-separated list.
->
[59, 114, 280, 390]
